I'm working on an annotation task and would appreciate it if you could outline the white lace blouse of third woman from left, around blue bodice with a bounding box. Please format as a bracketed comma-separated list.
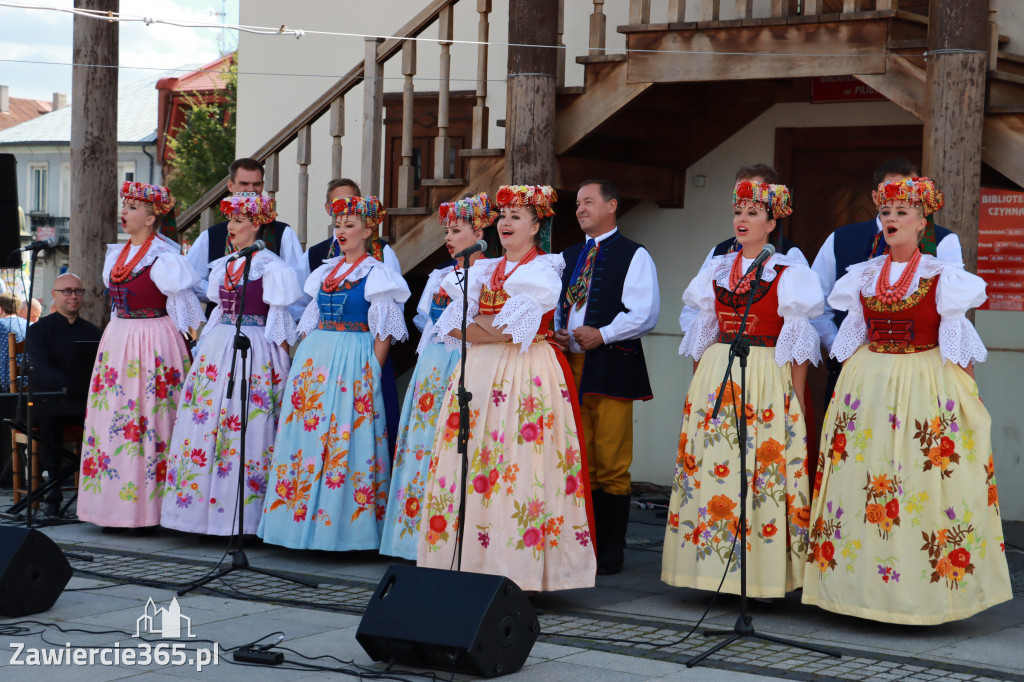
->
[298, 256, 410, 343]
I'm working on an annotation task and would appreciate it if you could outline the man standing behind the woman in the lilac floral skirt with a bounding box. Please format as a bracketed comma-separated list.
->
[185, 159, 303, 305]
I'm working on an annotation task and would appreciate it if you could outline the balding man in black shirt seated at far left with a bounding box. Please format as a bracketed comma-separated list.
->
[25, 272, 100, 515]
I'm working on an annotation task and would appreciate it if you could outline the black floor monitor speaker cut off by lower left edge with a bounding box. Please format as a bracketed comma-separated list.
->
[0, 526, 72, 616]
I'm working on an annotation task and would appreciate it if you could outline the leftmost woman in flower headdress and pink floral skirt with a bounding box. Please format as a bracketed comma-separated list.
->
[78, 182, 204, 527]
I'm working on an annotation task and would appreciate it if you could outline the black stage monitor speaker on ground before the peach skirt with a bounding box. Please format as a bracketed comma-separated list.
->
[355, 564, 541, 677]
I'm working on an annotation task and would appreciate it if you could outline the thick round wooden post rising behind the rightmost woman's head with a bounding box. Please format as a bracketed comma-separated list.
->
[923, 0, 989, 271]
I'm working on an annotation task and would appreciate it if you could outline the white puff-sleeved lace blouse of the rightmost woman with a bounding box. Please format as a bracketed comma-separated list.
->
[828, 255, 988, 367]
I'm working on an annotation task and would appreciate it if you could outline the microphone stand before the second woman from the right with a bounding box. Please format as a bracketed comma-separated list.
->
[686, 250, 843, 668]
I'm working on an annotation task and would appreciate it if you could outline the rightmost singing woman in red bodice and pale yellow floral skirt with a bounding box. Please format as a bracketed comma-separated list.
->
[803, 177, 1013, 625]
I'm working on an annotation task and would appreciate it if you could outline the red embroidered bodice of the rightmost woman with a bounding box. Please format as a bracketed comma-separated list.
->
[860, 275, 940, 353]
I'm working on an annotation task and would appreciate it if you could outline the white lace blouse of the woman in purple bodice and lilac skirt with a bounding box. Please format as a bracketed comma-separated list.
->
[203, 251, 302, 344]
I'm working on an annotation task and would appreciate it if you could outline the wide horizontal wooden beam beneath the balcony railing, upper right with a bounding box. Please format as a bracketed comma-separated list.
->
[627, 19, 888, 83]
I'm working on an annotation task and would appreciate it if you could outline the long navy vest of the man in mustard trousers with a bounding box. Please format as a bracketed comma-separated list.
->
[558, 231, 653, 400]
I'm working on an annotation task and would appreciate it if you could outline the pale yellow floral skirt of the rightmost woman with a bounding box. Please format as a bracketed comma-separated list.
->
[803, 347, 1013, 625]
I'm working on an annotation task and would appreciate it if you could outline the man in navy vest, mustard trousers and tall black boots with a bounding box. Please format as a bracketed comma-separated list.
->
[555, 180, 659, 574]
